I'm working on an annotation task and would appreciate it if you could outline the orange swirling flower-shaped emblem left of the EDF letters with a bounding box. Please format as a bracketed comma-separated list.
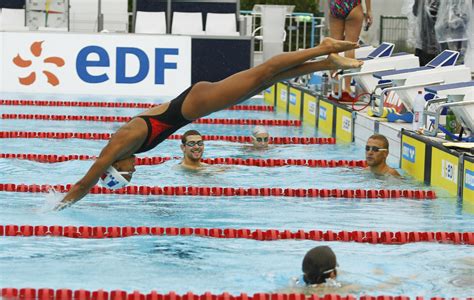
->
[13, 41, 64, 86]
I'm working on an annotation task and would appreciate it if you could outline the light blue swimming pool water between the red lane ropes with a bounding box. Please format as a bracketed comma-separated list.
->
[0, 95, 474, 297]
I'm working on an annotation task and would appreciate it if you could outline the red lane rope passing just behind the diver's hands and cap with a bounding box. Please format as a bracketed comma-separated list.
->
[0, 183, 436, 200]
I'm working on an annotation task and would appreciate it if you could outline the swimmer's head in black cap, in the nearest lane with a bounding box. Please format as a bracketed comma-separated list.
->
[303, 246, 337, 285]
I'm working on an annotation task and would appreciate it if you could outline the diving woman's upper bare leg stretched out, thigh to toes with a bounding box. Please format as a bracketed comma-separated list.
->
[182, 38, 357, 120]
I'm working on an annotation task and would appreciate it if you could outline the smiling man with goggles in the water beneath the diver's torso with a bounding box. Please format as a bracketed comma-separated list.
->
[181, 130, 207, 170]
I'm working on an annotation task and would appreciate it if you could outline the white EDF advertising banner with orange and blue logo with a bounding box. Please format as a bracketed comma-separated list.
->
[0, 32, 191, 96]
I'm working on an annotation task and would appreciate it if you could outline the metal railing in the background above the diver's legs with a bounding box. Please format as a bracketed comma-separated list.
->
[240, 10, 325, 51]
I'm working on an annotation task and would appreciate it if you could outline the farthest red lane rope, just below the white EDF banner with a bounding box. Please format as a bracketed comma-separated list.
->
[0, 99, 274, 111]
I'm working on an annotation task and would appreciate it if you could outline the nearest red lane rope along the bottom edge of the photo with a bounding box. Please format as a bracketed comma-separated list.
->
[0, 288, 464, 300]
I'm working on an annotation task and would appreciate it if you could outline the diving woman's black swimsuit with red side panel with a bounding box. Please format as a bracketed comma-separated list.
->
[135, 86, 192, 153]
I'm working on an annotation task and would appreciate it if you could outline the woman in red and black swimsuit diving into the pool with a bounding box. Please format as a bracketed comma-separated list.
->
[55, 38, 363, 210]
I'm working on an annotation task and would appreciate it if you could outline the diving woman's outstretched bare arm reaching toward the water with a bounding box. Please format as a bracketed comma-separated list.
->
[54, 126, 143, 210]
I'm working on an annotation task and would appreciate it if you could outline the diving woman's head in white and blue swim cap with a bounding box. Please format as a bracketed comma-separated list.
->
[99, 155, 135, 190]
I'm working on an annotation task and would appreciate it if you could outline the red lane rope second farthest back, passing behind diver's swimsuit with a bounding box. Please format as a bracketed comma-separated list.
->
[0, 114, 301, 126]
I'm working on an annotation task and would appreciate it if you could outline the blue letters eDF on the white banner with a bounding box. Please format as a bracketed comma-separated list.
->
[76, 46, 179, 84]
